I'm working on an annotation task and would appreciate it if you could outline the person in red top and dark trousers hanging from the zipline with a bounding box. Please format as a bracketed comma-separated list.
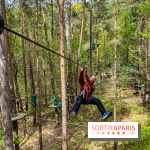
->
[70, 67, 112, 119]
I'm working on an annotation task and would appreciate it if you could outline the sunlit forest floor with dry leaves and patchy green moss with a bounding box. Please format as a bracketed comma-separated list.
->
[16, 79, 150, 150]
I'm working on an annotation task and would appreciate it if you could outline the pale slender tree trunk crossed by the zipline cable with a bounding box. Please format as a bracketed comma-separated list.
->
[58, 0, 67, 150]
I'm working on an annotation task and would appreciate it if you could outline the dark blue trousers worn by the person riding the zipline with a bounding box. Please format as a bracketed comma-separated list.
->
[71, 95, 106, 115]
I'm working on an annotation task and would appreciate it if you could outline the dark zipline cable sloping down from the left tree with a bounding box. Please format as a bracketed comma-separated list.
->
[4, 26, 83, 67]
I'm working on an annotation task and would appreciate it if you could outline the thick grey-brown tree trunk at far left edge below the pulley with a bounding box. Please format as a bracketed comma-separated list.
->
[0, 26, 14, 150]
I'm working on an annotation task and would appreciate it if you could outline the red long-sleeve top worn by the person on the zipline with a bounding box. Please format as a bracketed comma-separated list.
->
[79, 71, 95, 101]
